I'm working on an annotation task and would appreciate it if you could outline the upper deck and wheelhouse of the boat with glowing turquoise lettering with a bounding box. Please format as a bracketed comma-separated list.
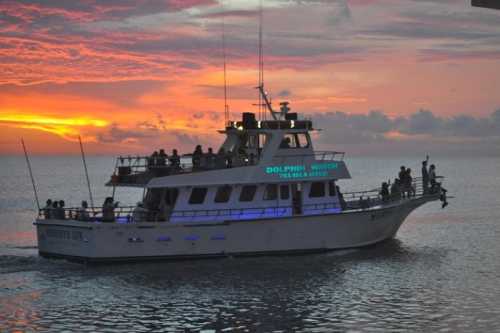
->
[107, 109, 350, 187]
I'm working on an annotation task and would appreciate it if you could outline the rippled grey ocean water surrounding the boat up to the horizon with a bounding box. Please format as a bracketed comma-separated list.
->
[0, 156, 500, 332]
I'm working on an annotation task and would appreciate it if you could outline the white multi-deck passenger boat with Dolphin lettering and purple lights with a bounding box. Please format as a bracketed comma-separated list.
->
[34, 94, 450, 262]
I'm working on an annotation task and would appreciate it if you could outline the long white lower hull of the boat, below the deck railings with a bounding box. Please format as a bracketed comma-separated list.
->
[35, 197, 435, 262]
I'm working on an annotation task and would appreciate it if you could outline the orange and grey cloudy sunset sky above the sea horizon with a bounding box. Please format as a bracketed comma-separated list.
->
[0, 0, 500, 155]
